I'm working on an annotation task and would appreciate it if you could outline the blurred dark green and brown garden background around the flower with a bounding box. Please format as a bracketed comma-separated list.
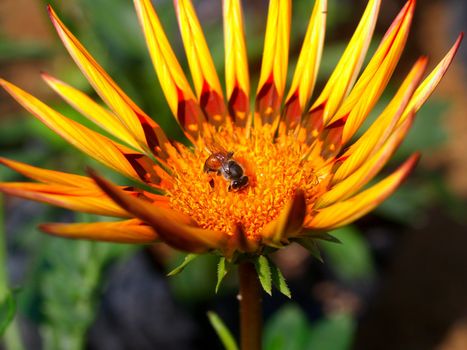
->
[0, 0, 467, 350]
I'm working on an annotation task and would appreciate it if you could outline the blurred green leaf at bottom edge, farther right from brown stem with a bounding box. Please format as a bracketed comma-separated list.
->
[303, 313, 356, 350]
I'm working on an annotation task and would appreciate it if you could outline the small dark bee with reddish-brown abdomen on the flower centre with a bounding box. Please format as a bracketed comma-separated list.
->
[203, 145, 248, 191]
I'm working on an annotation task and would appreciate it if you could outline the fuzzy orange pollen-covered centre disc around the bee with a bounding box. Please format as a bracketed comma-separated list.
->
[167, 123, 326, 240]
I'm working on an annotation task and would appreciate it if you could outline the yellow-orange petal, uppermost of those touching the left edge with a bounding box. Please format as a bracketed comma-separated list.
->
[0, 80, 150, 180]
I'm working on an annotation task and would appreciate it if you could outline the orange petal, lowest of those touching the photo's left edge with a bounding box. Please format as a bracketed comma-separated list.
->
[0, 182, 130, 217]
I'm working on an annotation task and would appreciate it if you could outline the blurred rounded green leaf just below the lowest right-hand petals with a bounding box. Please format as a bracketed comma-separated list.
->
[321, 226, 375, 281]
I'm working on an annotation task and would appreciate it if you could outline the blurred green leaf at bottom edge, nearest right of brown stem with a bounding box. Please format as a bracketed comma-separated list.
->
[264, 303, 312, 350]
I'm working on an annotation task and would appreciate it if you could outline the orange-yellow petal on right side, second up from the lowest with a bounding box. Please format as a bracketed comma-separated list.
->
[315, 113, 414, 209]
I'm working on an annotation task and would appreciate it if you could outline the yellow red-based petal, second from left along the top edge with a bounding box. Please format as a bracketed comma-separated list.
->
[174, 0, 226, 125]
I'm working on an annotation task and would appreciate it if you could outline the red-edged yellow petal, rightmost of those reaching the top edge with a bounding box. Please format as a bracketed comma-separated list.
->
[329, 0, 415, 144]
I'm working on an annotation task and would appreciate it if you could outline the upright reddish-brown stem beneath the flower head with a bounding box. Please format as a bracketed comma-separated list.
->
[238, 261, 263, 350]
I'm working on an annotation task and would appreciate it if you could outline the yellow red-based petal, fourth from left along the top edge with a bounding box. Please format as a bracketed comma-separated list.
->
[255, 0, 292, 129]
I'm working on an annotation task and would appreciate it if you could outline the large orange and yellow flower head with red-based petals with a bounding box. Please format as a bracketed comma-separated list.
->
[0, 0, 462, 258]
